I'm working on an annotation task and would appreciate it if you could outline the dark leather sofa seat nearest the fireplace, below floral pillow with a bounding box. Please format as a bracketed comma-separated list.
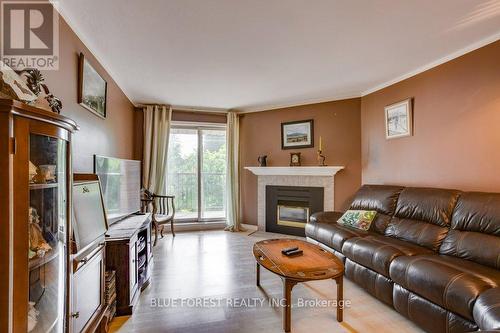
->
[306, 212, 374, 252]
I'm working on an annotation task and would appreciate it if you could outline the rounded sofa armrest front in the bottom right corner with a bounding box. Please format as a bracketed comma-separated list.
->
[472, 287, 500, 331]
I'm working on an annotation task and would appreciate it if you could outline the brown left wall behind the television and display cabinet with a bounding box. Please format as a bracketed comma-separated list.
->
[43, 13, 134, 172]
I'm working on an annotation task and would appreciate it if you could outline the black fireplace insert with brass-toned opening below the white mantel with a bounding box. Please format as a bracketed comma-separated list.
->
[266, 185, 324, 236]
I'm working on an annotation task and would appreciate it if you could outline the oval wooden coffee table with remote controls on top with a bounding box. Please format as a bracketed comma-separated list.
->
[253, 239, 344, 332]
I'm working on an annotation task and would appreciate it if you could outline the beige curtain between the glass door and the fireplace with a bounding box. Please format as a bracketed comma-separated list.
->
[225, 112, 245, 231]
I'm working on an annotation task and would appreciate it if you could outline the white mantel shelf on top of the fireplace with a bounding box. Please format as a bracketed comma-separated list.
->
[245, 166, 344, 177]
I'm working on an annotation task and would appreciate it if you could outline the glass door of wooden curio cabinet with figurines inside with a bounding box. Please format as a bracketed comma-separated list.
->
[27, 134, 68, 333]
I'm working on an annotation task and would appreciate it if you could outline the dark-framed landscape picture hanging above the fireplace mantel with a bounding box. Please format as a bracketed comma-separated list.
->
[281, 119, 314, 149]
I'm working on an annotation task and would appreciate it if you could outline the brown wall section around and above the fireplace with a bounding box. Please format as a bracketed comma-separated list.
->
[240, 98, 361, 224]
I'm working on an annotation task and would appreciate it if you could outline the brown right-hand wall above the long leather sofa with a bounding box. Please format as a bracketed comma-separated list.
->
[361, 41, 500, 192]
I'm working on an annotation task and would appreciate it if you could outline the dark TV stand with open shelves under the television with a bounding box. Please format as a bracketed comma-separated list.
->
[106, 213, 153, 316]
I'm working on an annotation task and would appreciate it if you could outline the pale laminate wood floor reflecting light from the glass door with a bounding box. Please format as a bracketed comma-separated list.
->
[111, 231, 422, 333]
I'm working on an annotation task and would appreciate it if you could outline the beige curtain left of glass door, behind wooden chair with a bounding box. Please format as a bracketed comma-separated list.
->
[142, 105, 172, 195]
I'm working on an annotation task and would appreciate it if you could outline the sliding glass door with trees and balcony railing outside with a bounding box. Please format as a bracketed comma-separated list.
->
[167, 126, 227, 222]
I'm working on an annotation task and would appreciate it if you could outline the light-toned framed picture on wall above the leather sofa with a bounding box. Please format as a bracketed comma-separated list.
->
[385, 98, 413, 139]
